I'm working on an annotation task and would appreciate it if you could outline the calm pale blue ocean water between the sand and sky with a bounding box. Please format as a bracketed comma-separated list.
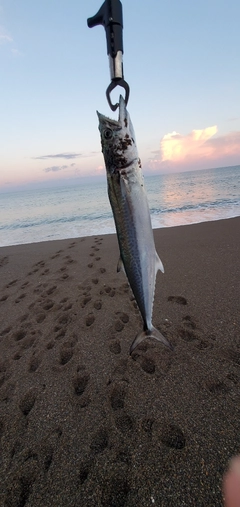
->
[0, 166, 240, 246]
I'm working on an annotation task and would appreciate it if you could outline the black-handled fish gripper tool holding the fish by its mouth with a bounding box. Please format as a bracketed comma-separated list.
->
[87, 0, 130, 111]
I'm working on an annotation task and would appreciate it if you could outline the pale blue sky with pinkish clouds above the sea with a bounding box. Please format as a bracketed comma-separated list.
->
[0, 0, 240, 192]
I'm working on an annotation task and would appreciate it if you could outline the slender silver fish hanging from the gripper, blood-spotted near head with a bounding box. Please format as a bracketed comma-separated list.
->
[97, 96, 173, 354]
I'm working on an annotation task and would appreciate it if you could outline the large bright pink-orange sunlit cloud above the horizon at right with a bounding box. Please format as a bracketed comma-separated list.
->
[148, 125, 240, 170]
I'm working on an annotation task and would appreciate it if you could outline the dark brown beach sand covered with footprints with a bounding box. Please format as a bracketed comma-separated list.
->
[0, 218, 240, 507]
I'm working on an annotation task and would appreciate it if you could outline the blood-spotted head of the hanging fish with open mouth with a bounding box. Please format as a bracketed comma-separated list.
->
[97, 96, 138, 173]
